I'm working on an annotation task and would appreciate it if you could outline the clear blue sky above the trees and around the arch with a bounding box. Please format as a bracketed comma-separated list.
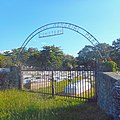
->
[0, 0, 120, 56]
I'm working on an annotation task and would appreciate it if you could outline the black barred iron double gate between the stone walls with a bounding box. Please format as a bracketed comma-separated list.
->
[21, 63, 96, 99]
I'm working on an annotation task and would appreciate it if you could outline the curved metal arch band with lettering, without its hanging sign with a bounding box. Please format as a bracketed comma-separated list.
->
[20, 22, 103, 58]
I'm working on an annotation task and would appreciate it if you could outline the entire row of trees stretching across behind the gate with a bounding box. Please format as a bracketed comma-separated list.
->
[0, 38, 120, 70]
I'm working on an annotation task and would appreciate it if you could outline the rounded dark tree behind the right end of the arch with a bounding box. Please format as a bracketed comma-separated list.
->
[77, 43, 113, 65]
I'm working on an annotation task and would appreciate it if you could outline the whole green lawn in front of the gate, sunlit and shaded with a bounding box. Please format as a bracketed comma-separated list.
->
[0, 90, 110, 120]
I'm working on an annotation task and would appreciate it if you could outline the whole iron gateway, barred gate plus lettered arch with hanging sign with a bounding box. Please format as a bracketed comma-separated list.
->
[18, 22, 100, 99]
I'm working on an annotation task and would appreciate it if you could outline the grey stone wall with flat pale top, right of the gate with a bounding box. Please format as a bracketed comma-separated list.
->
[96, 72, 120, 116]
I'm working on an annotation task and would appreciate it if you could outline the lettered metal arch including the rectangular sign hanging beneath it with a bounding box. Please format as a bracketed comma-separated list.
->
[20, 22, 103, 58]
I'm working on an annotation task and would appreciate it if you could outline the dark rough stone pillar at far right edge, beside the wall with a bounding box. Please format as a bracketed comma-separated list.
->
[112, 80, 120, 120]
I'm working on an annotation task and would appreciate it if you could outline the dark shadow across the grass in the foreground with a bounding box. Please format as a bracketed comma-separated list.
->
[8, 102, 112, 120]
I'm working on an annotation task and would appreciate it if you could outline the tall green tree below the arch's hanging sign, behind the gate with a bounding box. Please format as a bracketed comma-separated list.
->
[39, 45, 63, 69]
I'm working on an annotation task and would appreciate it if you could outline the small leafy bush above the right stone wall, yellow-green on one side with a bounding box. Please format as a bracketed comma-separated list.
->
[98, 61, 118, 72]
